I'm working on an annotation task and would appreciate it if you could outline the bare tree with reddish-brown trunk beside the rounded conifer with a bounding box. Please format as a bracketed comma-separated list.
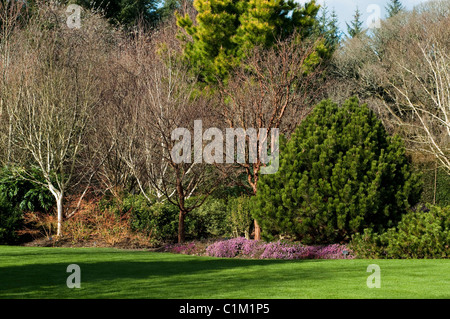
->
[219, 35, 324, 240]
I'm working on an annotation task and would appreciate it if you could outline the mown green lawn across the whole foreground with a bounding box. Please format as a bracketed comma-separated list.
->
[0, 246, 450, 299]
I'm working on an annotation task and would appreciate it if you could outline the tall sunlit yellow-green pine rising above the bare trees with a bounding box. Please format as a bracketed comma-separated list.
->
[177, 0, 319, 83]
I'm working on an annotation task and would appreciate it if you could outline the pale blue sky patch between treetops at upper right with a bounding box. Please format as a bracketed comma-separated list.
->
[298, 0, 428, 33]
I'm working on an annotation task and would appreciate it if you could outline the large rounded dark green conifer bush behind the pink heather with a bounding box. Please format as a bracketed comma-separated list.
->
[252, 97, 422, 244]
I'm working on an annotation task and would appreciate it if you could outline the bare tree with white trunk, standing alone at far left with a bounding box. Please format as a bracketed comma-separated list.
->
[6, 5, 112, 236]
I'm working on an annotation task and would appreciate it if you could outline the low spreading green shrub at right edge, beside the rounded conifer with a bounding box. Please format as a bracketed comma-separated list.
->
[351, 205, 450, 258]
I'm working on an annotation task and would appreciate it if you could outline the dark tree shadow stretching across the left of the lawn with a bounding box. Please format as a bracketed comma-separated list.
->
[0, 254, 344, 298]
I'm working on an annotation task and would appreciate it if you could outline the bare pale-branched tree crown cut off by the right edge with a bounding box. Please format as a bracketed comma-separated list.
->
[380, 6, 450, 174]
